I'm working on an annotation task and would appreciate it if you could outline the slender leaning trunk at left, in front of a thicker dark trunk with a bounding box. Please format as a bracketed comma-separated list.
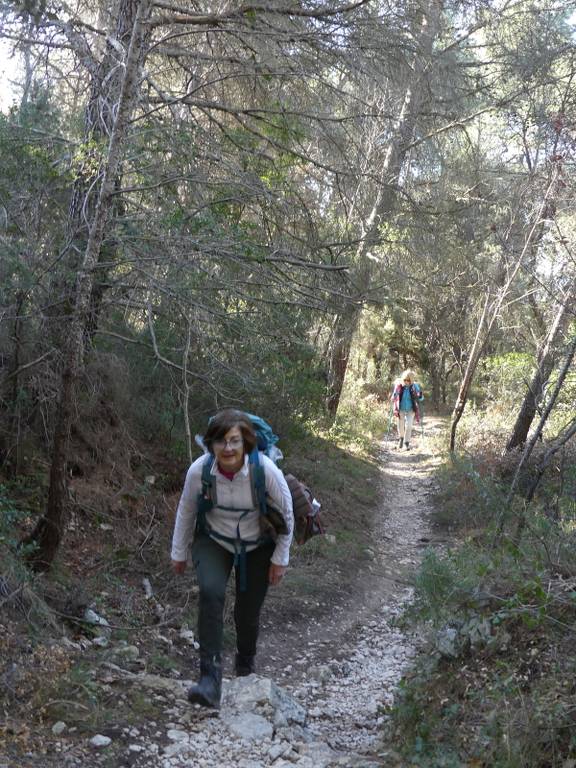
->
[26, 0, 149, 570]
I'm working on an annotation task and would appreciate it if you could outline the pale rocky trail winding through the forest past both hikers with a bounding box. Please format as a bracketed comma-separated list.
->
[5, 419, 440, 768]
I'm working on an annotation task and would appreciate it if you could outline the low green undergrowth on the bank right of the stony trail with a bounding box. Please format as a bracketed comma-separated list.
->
[389, 412, 576, 768]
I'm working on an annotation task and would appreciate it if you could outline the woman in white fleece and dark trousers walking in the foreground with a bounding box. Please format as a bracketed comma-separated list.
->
[172, 409, 294, 707]
